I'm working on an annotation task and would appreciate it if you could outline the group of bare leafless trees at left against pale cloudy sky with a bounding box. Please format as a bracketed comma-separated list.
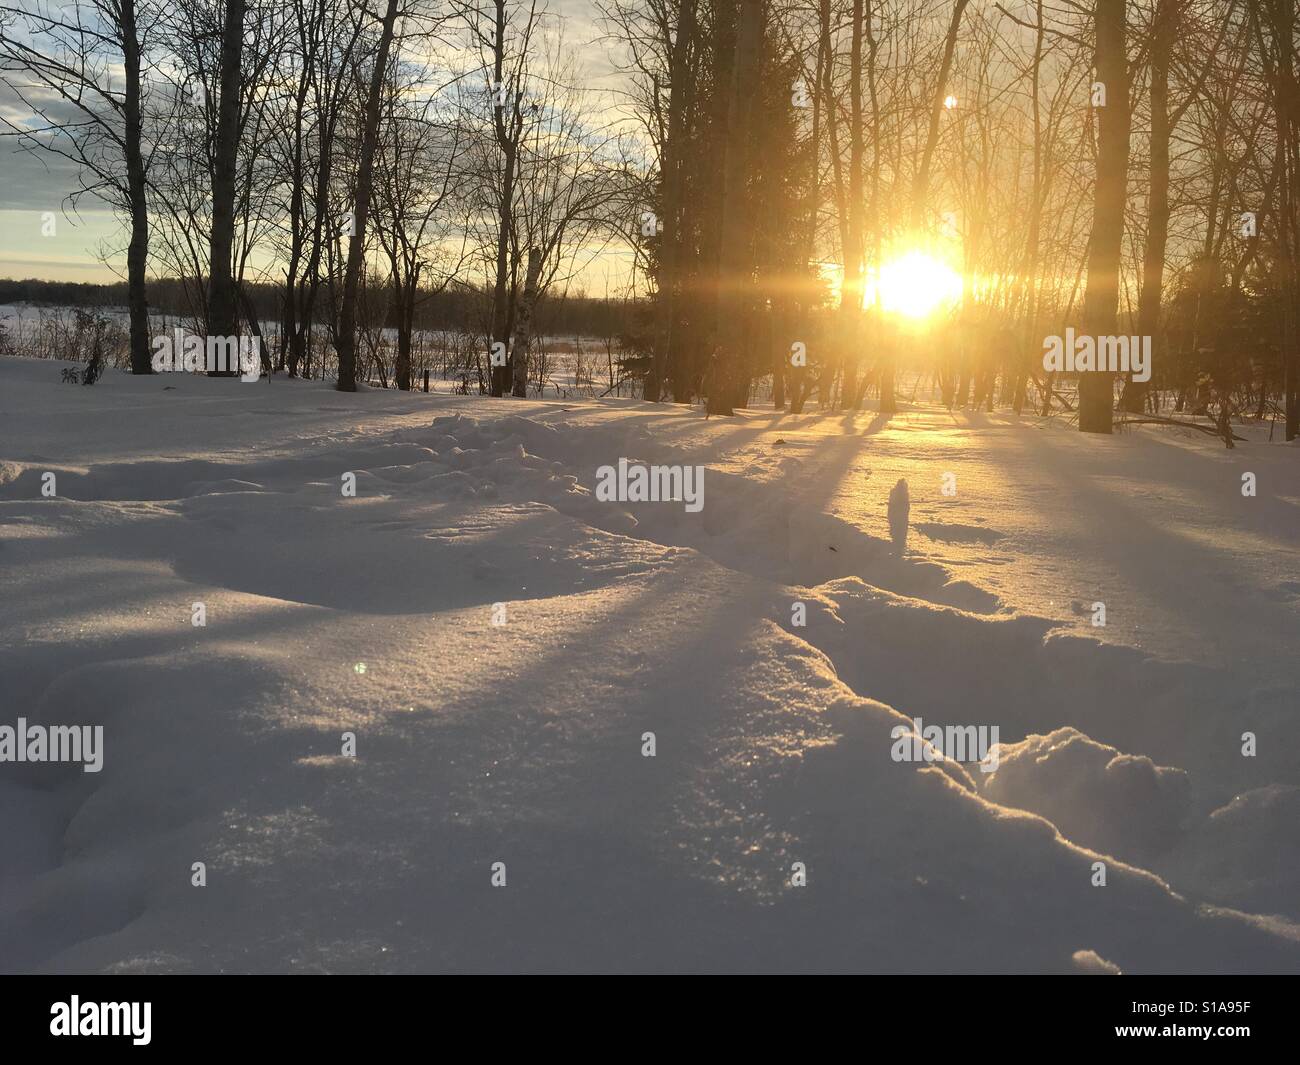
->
[0, 0, 645, 395]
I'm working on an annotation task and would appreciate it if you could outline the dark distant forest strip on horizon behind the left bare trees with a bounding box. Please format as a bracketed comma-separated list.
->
[0, 278, 645, 337]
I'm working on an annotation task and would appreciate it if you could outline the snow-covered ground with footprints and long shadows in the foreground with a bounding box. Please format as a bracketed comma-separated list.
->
[0, 359, 1300, 973]
